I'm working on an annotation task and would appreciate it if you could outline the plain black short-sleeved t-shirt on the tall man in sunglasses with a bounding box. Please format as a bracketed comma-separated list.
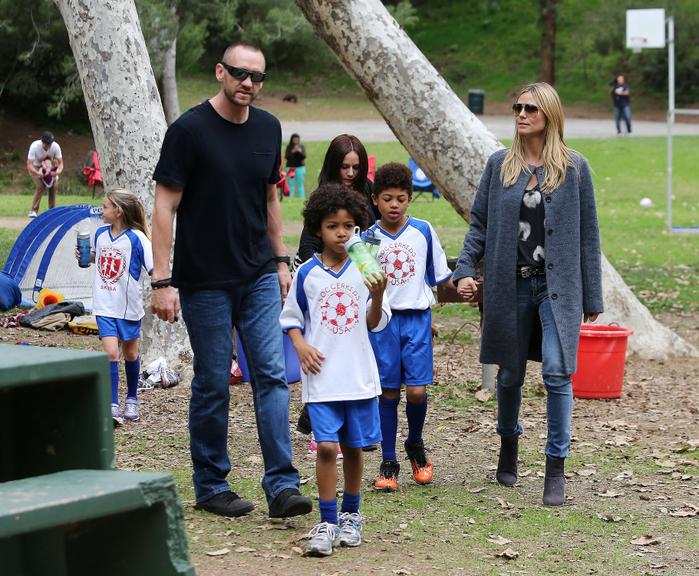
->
[153, 101, 282, 289]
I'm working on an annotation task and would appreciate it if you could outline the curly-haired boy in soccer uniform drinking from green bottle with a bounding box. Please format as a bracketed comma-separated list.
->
[280, 184, 391, 556]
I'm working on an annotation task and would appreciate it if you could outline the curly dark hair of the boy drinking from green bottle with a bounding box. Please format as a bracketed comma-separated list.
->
[303, 184, 369, 234]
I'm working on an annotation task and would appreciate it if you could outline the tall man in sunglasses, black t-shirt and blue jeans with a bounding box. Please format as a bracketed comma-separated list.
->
[151, 43, 312, 517]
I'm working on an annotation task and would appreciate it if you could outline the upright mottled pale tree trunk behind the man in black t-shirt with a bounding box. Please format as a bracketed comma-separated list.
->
[54, 0, 189, 363]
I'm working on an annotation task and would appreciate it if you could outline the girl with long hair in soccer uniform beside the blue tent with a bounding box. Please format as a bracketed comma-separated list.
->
[81, 189, 153, 425]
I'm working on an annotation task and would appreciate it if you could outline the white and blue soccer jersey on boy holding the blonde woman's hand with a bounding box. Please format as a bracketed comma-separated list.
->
[370, 216, 452, 310]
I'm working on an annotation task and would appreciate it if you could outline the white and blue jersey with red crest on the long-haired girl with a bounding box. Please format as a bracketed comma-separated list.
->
[92, 226, 153, 320]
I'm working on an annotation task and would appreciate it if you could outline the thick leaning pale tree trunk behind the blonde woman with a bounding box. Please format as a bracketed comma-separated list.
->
[296, 0, 697, 358]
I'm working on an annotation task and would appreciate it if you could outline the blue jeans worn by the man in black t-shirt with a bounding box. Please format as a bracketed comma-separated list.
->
[180, 273, 299, 503]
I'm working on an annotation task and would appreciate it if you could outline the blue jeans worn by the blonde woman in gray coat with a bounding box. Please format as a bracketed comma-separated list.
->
[497, 276, 573, 458]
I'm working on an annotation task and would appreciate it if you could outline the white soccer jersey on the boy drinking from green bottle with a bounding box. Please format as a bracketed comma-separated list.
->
[279, 256, 391, 402]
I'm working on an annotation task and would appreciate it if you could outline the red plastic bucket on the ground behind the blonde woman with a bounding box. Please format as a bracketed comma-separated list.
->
[573, 324, 633, 398]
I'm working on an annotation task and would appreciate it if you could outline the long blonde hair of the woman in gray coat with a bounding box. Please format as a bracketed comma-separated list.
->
[500, 82, 575, 192]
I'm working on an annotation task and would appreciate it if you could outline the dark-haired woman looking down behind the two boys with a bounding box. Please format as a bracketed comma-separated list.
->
[293, 134, 381, 269]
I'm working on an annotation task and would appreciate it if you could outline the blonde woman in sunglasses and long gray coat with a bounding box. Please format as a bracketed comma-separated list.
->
[452, 82, 603, 506]
